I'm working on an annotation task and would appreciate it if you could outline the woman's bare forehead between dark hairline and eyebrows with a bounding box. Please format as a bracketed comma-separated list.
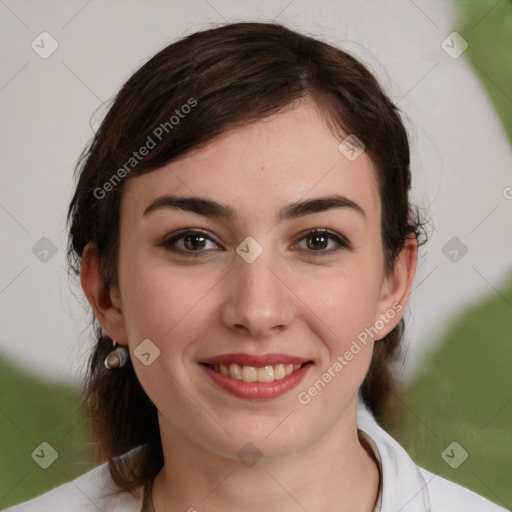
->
[122, 103, 380, 221]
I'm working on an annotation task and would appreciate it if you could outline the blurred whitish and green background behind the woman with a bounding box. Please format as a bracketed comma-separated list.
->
[0, 0, 512, 506]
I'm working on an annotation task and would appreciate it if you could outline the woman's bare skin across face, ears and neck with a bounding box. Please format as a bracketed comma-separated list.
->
[81, 101, 417, 512]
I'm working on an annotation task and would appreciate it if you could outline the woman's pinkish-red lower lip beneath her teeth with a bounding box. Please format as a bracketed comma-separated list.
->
[201, 363, 311, 400]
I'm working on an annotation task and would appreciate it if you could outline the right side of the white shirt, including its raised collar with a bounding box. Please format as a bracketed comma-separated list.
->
[357, 404, 506, 512]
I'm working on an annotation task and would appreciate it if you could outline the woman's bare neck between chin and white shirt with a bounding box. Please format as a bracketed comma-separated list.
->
[152, 407, 379, 512]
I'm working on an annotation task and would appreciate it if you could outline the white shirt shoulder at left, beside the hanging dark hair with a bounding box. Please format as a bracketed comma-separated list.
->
[4, 452, 142, 512]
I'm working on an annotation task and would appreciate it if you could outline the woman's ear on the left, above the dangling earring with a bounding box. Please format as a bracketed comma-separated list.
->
[80, 242, 128, 345]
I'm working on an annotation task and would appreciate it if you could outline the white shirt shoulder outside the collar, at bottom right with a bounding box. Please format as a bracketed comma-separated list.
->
[419, 468, 507, 512]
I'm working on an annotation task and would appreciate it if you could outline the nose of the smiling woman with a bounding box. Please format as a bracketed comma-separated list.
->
[222, 251, 295, 339]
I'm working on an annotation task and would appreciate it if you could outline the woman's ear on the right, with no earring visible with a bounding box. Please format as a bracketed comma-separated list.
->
[375, 235, 418, 340]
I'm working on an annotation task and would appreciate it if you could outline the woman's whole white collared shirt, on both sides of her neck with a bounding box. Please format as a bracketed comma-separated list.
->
[5, 404, 507, 512]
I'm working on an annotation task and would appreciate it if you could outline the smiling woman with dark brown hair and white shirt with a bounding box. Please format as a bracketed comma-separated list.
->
[6, 23, 504, 512]
